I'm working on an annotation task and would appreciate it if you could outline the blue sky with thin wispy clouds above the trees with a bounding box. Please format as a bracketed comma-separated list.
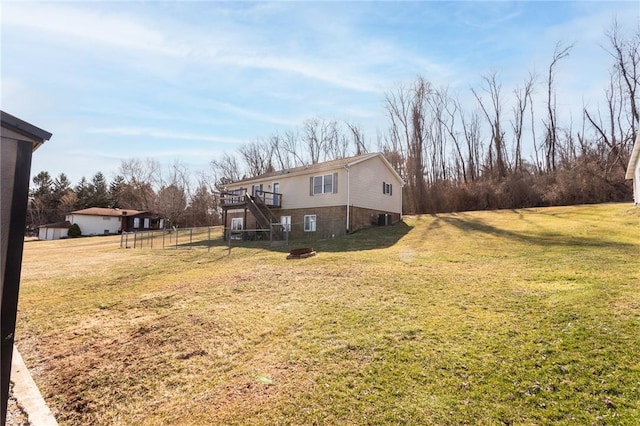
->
[0, 0, 640, 184]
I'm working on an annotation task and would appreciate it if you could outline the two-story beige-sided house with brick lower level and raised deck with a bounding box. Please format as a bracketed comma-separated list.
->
[222, 153, 403, 238]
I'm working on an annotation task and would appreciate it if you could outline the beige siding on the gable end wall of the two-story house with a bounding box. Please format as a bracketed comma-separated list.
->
[350, 157, 402, 213]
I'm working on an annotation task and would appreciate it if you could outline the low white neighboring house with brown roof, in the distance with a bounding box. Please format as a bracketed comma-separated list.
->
[66, 207, 164, 235]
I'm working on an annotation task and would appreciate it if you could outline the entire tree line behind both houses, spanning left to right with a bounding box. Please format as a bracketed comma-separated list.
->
[29, 22, 640, 230]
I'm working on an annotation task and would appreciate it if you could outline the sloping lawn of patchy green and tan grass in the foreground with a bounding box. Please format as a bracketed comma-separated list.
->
[17, 204, 640, 425]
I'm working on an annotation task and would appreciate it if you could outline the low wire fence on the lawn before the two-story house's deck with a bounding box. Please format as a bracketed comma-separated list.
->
[120, 221, 345, 251]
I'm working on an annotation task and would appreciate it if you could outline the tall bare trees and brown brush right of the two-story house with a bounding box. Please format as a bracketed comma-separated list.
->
[381, 23, 640, 213]
